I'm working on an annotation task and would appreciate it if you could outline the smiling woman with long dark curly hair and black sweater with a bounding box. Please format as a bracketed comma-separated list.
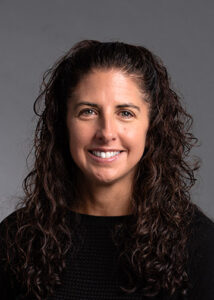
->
[0, 40, 214, 300]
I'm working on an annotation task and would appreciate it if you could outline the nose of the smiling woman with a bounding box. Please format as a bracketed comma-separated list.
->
[96, 117, 116, 143]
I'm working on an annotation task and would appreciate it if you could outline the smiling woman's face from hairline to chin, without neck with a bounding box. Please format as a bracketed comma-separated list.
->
[66, 70, 149, 184]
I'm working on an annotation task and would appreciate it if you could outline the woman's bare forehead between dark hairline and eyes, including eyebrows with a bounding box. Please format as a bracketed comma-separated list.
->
[67, 69, 150, 116]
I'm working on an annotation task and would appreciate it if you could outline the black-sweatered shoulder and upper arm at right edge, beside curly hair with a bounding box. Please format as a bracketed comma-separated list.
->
[186, 209, 214, 300]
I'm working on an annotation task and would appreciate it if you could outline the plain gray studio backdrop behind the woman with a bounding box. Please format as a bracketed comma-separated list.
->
[0, 0, 214, 219]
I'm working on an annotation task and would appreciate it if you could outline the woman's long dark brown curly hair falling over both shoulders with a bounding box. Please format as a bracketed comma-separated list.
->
[2, 40, 200, 300]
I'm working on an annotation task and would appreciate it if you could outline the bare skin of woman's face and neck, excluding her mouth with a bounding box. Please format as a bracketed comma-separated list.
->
[66, 69, 149, 216]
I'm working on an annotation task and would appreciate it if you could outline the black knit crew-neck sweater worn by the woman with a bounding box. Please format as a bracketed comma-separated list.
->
[0, 207, 214, 300]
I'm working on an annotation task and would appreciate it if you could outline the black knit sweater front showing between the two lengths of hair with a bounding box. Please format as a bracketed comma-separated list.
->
[50, 212, 142, 300]
